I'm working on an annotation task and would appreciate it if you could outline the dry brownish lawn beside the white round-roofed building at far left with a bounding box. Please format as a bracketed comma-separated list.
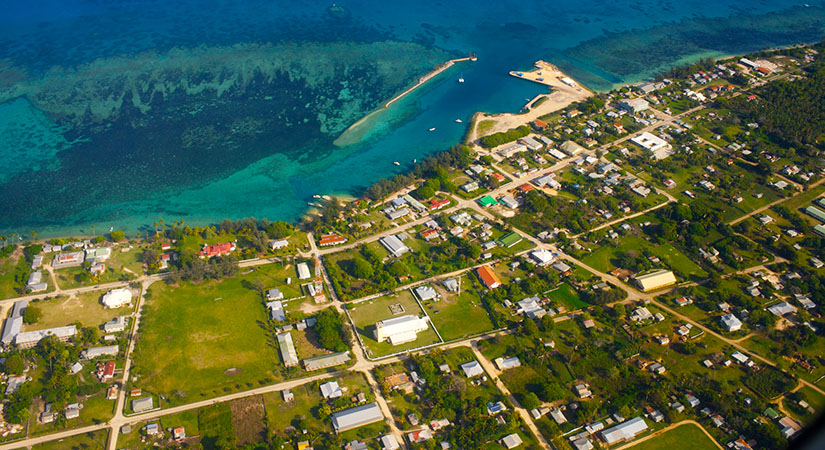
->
[26, 291, 137, 331]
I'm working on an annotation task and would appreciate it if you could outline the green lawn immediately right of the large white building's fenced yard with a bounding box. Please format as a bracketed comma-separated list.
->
[422, 275, 494, 341]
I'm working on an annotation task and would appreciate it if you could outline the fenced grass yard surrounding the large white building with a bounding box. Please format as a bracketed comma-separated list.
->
[347, 290, 439, 358]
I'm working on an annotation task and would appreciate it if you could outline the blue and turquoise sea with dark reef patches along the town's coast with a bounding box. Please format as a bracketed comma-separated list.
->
[0, 0, 825, 236]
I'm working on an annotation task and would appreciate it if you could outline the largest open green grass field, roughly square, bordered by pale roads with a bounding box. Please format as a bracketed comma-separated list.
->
[133, 273, 282, 406]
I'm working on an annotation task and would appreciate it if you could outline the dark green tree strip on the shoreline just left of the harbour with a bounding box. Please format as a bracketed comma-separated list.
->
[364, 145, 473, 200]
